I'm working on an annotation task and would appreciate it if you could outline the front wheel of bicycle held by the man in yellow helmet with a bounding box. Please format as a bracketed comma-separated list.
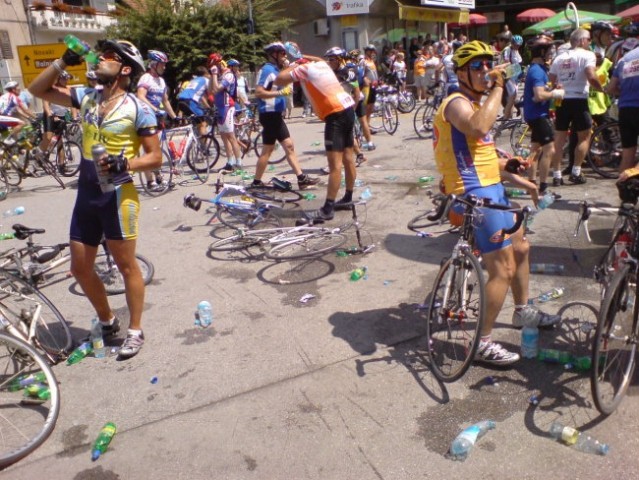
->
[425, 251, 486, 382]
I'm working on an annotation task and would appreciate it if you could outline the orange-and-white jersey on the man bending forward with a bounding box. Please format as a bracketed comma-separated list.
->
[291, 62, 355, 120]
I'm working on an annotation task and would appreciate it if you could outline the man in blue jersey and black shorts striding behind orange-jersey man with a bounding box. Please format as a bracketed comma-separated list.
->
[253, 42, 319, 190]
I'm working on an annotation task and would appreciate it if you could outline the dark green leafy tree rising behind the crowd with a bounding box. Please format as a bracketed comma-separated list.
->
[107, 0, 292, 91]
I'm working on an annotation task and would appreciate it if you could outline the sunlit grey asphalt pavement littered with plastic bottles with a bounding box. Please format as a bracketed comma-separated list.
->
[0, 104, 639, 480]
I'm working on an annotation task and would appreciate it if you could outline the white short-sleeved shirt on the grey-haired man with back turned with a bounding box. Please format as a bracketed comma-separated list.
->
[550, 48, 597, 98]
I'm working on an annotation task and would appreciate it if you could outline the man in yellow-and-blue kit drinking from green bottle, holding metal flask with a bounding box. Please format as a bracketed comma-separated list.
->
[29, 40, 162, 360]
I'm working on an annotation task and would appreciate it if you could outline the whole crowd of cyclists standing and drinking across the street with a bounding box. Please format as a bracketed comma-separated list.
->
[0, 16, 639, 365]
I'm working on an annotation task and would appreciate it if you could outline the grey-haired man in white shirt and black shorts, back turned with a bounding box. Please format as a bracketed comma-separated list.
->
[549, 28, 603, 187]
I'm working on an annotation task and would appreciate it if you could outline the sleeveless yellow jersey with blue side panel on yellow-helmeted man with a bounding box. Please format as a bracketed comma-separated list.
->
[433, 93, 501, 194]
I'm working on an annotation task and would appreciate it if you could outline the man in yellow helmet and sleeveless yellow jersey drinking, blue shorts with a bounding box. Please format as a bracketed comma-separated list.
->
[433, 41, 560, 365]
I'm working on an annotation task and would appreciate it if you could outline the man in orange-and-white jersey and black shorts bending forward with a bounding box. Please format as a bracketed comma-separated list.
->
[274, 42, 355, 222]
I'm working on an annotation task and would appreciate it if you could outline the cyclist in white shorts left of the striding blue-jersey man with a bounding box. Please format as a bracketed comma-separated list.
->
[209, 53, 242, 172]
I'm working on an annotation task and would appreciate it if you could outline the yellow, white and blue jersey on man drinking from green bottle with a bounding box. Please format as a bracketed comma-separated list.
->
[71, 87, 157, 186]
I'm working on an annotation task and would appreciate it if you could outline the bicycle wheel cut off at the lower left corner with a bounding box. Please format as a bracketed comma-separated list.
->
[0, 332, 60, 470]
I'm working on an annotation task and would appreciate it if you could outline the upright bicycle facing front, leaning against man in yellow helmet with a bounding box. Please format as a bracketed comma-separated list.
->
[424, 195, 532, 382]
